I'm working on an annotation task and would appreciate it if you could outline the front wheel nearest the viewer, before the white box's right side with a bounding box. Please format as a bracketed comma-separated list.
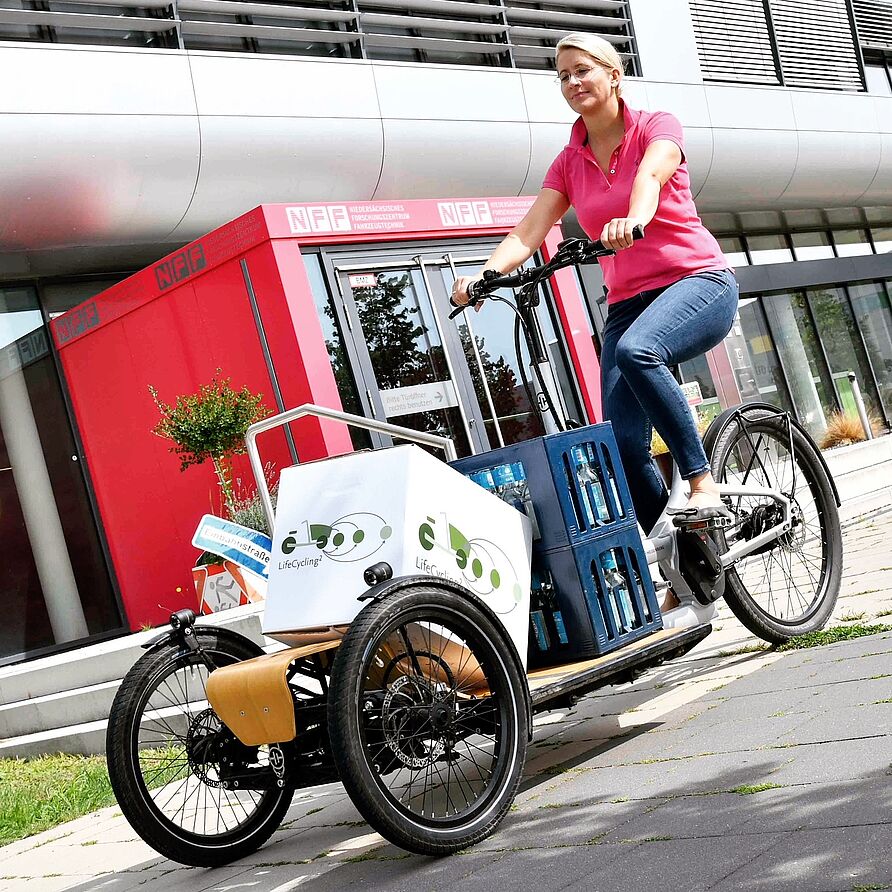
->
[328, 585, 527, 855]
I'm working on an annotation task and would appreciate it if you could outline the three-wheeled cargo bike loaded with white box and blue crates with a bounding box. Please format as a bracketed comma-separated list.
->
[107, 235, 842, 866]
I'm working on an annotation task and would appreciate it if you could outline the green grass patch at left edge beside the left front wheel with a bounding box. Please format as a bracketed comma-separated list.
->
[0, 754, 115, 846]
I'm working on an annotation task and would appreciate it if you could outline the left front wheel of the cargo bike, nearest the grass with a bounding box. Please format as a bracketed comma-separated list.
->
[107, 629, 294, 867]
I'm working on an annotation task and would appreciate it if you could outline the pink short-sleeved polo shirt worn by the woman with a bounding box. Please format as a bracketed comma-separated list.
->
[542, 102, 731, 304]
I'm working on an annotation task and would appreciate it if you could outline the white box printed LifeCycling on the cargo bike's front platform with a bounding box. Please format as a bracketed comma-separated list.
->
[263, 445, 531, 664]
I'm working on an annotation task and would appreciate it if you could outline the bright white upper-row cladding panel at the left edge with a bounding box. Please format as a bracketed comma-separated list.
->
[0, 44, 195, 116]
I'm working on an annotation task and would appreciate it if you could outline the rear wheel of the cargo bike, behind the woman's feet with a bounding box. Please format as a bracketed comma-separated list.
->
[711, 409, 842, 644]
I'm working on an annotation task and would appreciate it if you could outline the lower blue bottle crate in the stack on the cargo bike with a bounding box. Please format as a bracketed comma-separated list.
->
[527, 528, 663, 669]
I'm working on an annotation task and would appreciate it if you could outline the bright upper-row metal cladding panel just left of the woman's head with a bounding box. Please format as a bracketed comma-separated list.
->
[375, 62, 528, 127]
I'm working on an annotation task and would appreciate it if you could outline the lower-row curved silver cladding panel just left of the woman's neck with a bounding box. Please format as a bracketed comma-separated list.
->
[374, 120, 530, 199]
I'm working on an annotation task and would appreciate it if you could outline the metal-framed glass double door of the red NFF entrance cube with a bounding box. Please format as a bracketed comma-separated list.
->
[324, 246, 584, 456]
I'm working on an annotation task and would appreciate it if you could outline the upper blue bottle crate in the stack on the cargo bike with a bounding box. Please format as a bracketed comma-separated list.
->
[451, 422, 635, 551]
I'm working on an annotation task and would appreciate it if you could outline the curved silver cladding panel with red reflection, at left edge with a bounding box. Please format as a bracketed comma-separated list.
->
[0, 114, 199, 251]
